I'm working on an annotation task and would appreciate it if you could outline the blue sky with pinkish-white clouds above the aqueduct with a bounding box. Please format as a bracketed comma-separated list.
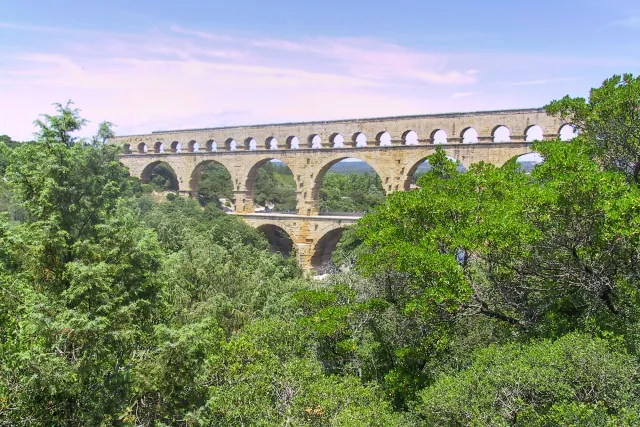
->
[0, 0, 640, 140]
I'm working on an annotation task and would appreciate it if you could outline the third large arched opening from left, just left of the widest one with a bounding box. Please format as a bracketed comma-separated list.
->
[247, 159, 296, 213]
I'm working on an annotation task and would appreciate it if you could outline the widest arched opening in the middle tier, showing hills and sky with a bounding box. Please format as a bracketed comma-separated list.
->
[313, 158, 386, 213]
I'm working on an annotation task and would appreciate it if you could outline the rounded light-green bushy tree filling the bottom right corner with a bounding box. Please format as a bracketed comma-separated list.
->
[417, 334, 640, 426]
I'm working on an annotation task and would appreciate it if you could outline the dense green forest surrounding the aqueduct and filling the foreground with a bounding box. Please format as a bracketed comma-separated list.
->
[0, 75, 640, 426]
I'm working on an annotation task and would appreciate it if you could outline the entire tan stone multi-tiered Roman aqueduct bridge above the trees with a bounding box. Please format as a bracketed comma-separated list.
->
[112, 109, 563, 269]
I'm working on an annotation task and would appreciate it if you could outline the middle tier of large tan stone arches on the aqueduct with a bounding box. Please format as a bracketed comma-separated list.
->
[121, 143, 531, 216]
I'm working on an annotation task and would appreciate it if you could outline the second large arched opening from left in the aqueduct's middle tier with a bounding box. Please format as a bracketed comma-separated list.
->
[191, 160, 235, 212]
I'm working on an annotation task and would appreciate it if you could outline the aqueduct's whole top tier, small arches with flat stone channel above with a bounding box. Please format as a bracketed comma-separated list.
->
[112, 108, 563, 154]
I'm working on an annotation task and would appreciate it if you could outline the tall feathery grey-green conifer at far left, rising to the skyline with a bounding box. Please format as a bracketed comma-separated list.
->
[0, 103, 161, 425]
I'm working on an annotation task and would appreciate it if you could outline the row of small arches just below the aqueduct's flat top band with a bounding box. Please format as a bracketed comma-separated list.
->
[116, 124, 576, 154]
